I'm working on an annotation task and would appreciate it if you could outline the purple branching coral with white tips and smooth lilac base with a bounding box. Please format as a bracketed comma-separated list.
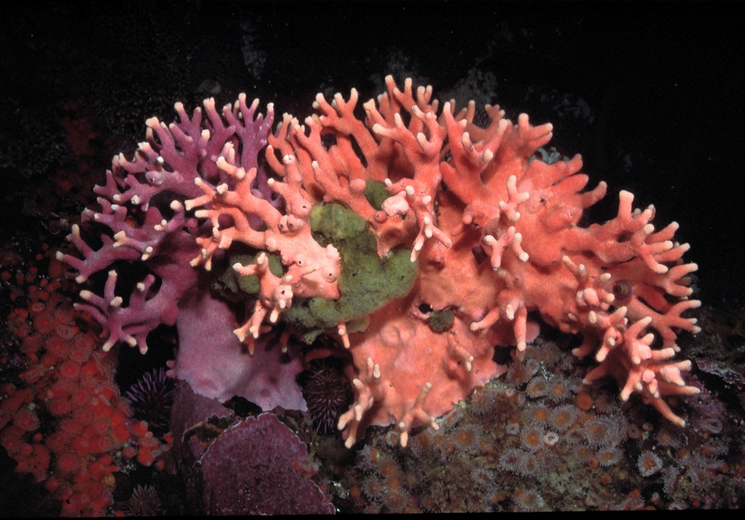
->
[57, 95, 305, 409]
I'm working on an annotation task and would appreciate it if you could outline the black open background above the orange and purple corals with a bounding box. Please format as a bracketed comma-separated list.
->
[0, 1, 745, 305]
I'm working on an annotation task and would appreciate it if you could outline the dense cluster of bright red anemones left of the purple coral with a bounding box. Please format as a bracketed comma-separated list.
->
[0, 252, 163, 516]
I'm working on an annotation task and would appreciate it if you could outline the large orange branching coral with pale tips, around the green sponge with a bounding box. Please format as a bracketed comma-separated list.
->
[187, 77, 699, 445]
